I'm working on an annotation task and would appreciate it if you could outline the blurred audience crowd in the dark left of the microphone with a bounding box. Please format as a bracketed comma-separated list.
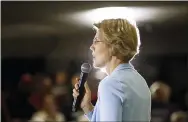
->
[2, 71, 96, 122]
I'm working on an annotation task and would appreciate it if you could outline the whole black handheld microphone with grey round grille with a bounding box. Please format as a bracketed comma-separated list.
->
[72, 63, 92, 112]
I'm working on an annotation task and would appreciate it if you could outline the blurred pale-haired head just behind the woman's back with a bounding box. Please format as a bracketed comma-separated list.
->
[150, 81, 171, 102]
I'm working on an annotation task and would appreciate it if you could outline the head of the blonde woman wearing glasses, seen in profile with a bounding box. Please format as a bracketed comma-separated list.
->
[90, 19, 140, 73]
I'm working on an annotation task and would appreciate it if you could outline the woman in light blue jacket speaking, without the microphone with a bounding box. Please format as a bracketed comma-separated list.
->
[73, 19, 151, 122]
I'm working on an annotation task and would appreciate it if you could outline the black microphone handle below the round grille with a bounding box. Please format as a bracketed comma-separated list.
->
[72, 72, 88, 112]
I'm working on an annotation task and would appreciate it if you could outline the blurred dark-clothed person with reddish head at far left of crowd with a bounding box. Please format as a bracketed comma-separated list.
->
[6, 73, 35, 121]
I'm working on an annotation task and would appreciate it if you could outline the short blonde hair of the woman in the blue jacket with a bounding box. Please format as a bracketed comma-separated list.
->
[94, 19, 140, 62]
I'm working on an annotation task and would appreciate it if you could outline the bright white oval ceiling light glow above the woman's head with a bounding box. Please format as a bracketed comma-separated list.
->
[59, 6, 186, 26]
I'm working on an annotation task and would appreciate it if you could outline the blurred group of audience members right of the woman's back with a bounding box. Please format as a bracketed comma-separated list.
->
[150, 81, 188, 122]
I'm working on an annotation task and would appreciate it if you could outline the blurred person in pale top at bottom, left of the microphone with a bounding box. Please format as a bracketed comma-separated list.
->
[31, 93, 65, 122]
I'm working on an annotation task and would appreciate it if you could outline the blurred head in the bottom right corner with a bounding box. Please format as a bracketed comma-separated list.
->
[170, 111, 188, 122]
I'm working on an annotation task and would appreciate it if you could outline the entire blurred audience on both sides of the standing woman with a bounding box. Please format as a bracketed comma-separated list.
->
[1, 71, 188, 122]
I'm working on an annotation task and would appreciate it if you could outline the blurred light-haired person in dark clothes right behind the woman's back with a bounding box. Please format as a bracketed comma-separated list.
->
[150, 81, 177, 122]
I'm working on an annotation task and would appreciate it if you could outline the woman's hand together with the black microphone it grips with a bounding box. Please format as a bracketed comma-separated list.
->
[72, 63, 93, 113]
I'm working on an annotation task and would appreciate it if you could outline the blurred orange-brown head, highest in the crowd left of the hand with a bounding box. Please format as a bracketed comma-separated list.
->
[55, 71, 67, 85]
